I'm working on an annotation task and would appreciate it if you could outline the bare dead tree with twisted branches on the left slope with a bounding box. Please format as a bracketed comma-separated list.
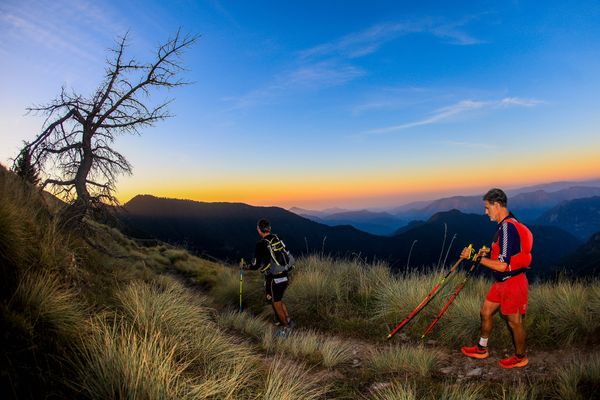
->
[17, 32, 198, 217]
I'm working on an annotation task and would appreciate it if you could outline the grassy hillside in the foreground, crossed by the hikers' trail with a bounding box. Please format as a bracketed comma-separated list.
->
[0, 168, 600, 400]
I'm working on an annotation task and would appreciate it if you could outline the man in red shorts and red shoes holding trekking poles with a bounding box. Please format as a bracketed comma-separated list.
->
[461, 189, 533, 368]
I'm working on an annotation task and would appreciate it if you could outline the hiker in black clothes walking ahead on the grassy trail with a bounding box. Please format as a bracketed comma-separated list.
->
[244, 219, 291, 329]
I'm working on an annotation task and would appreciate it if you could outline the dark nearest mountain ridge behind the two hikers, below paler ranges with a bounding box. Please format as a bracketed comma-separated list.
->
[122, 195, 582, 274]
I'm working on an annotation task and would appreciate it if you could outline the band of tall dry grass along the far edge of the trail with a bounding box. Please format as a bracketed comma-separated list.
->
[211, 256, 600, 347]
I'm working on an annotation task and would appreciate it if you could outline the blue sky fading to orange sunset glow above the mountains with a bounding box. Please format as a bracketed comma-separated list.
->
[0, 0, 600, 209]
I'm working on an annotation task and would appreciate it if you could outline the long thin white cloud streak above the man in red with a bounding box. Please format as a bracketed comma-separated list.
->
[363, 97, 543, 135]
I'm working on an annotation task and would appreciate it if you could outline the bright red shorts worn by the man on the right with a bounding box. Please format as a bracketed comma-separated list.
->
[485, 273, 529, 315]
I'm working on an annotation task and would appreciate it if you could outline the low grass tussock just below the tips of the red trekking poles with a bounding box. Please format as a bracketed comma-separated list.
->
[368, 345, 443, 377]
